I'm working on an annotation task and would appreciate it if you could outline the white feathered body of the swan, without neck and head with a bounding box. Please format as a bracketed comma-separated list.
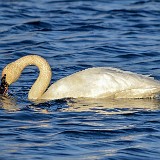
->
[42, 67, 160, 99]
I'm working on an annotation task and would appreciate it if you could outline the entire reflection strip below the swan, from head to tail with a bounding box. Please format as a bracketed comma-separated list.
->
[0, 96, 160, 114]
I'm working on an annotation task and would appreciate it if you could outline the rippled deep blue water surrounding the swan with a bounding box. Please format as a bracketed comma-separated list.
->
[0, 0, 160, 160]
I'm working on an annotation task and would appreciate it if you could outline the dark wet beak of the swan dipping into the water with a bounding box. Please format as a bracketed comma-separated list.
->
[0, 74, 9, 96]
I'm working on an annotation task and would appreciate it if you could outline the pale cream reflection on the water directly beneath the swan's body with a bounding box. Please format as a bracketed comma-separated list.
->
[64, 99, 160, 114]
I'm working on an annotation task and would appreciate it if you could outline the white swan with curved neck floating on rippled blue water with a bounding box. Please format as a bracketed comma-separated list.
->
[2, 55, 160, 100]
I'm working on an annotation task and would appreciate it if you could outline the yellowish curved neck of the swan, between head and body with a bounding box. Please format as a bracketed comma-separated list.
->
[15, 55, 52, 99]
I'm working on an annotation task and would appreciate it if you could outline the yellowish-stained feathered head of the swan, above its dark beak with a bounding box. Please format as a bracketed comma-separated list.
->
[2, 62, 21, 85]
